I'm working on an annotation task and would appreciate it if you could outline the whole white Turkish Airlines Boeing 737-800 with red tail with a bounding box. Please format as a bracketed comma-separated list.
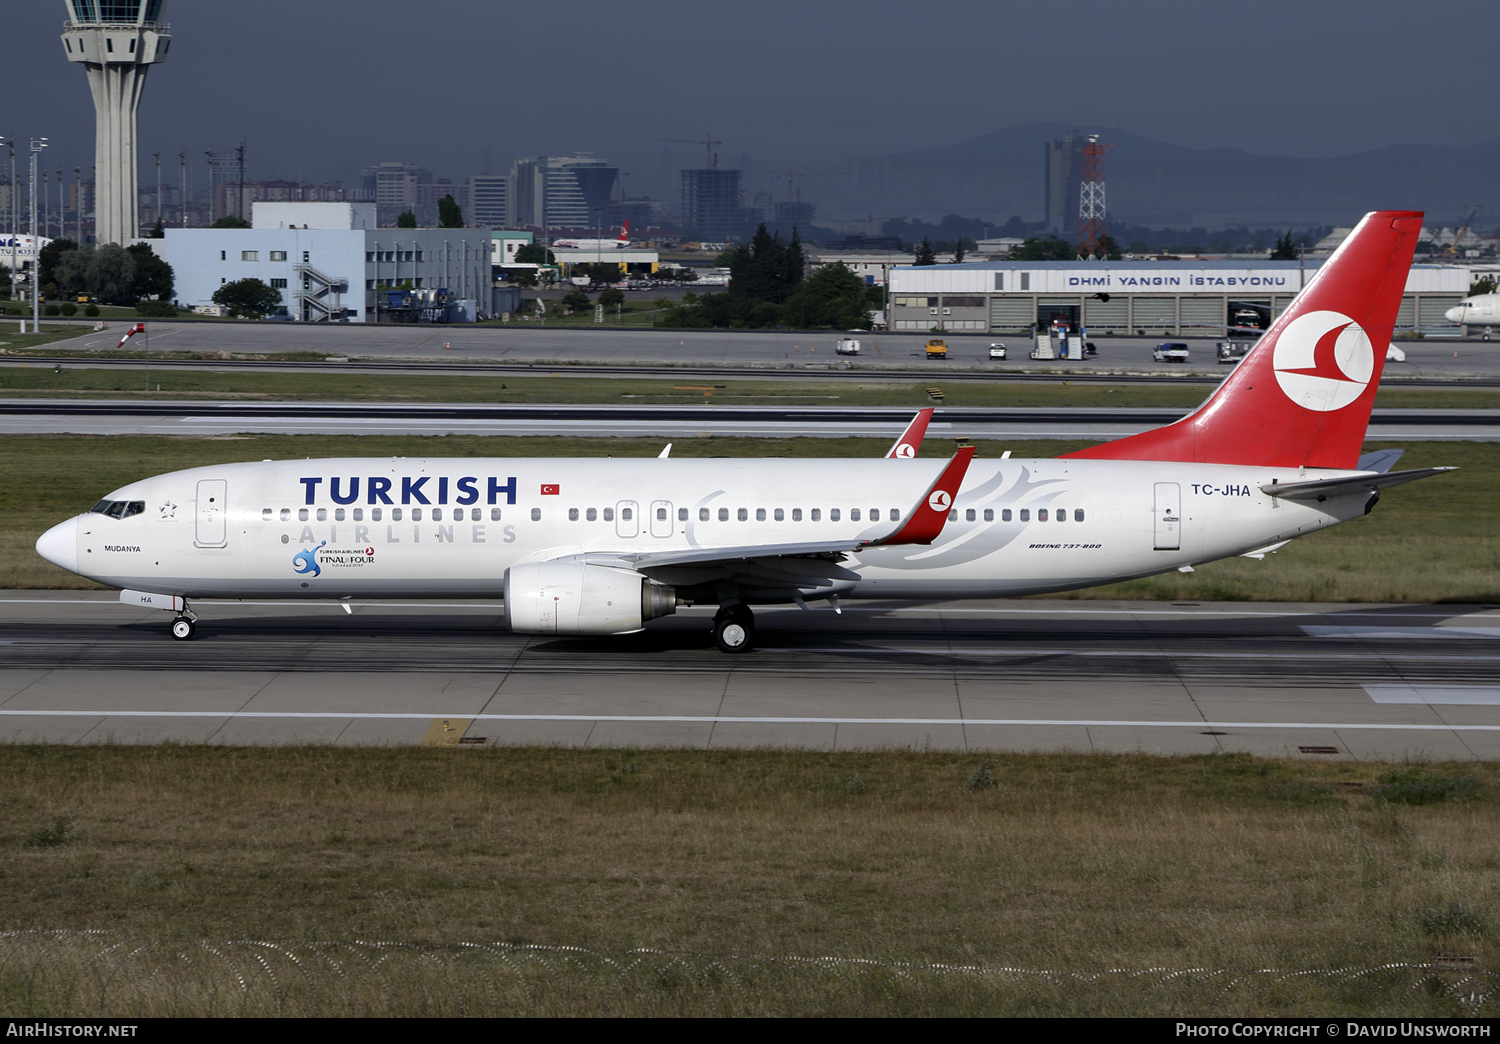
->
[36, 212, 1440, 653]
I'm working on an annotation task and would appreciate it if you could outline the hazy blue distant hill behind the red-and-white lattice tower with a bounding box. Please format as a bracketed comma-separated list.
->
[851, 123, 1500, 228]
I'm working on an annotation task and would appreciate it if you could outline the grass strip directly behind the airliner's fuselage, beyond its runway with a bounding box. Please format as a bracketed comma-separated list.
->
[0, 435, 1500, 603]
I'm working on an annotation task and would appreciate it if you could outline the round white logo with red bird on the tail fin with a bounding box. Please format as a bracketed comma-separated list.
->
[1271, 312, 1376, 413]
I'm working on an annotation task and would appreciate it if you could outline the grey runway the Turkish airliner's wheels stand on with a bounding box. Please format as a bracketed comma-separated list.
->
[0, 591, 1500, 759]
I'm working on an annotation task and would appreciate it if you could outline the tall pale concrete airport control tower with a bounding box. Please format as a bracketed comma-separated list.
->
[63, 0, 173, 246]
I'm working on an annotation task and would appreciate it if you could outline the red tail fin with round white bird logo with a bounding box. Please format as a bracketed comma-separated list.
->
[1067, 210, 1422, 468]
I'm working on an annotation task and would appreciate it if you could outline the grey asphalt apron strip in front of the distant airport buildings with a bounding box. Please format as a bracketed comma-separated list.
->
[20, 321, 1500, 380]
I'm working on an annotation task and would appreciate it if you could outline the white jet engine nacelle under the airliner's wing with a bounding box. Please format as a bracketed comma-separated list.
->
[506, 561, 677, 635]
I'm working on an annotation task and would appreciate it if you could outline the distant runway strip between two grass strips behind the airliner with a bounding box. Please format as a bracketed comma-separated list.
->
[0, 399, 1500, 441]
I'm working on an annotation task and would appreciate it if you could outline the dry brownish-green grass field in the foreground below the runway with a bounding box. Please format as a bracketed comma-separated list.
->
[0, 746, 1500, 1017]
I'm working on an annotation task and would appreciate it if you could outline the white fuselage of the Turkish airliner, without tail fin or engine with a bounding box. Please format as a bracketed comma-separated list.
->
[39, 458, 1370, 599]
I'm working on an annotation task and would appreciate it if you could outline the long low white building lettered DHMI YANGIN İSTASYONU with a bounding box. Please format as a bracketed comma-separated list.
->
[890, 261, 1470, 336]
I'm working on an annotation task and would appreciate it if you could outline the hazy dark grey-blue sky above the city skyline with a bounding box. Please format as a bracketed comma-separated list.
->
[14, 0, 1500, 205]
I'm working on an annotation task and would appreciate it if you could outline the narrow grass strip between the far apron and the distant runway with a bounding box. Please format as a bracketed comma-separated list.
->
[0, 364, 1500, 411]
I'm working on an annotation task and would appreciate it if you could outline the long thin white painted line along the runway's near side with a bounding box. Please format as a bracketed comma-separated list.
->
[0, 710, 1500, 732]
